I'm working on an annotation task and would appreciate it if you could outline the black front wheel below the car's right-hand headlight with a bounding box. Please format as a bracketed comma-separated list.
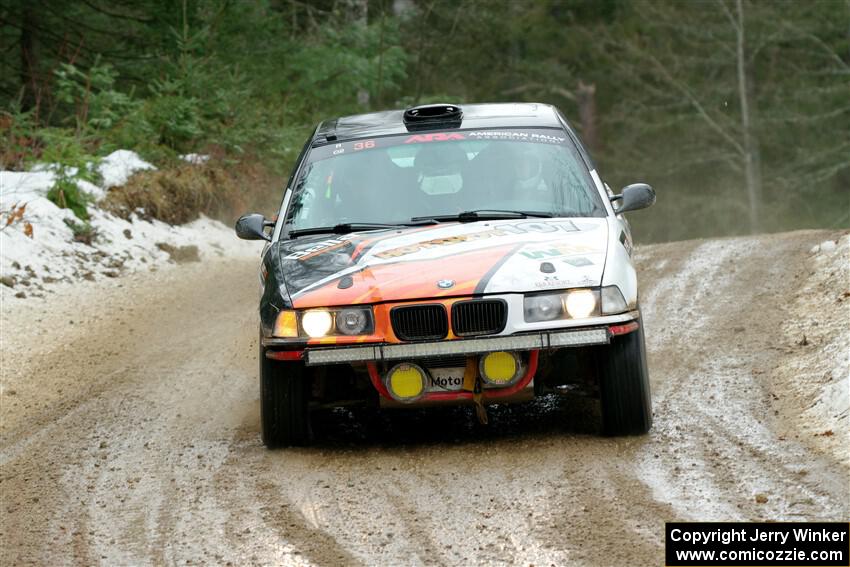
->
[597, 320, 652, 435]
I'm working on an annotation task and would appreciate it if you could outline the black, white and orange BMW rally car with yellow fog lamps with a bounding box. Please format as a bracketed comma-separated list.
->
[236, 103, 655, 447]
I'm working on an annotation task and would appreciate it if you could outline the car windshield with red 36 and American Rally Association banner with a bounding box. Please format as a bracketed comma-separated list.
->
[287, 128, 605, 230]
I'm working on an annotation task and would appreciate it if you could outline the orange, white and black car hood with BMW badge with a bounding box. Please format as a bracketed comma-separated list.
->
[278, 218, 608, 308]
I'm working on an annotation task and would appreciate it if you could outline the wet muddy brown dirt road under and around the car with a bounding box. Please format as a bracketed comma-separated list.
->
[0, 231, 850, 566]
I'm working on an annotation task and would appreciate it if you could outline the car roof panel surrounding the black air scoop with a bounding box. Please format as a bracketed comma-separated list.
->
[312, 102, 565, 146]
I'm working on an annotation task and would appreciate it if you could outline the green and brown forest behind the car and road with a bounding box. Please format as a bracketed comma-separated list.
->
[0, 0, 850, 242]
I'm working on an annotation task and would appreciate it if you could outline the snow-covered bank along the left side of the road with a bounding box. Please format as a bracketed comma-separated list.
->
[0, 150, 259, 301]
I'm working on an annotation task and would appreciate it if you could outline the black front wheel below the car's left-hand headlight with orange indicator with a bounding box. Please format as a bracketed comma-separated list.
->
[260, 345, 311, 449]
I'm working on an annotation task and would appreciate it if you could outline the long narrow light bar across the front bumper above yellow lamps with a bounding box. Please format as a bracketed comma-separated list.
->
[294, 326, 611, 366]
